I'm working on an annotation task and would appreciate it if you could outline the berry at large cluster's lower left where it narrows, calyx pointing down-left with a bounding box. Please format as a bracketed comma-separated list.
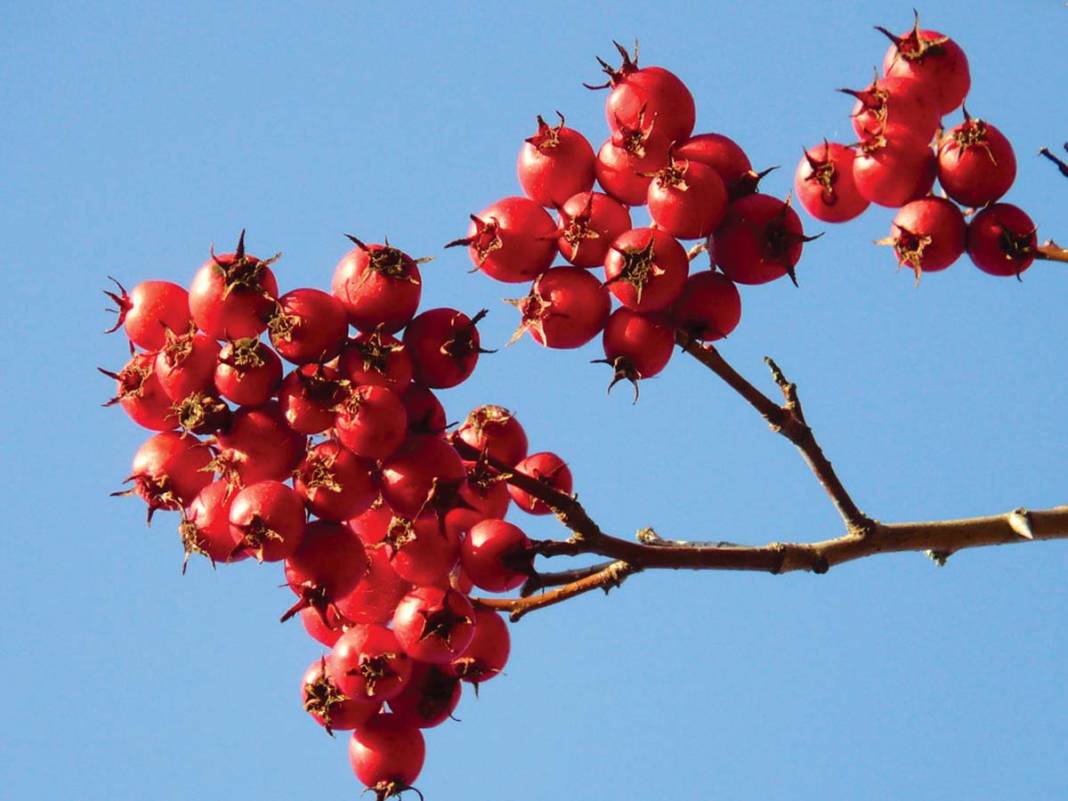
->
[282, 520, 367, 621]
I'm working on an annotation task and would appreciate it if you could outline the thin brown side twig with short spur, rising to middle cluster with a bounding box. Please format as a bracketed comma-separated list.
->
[676, 331, 873, 536]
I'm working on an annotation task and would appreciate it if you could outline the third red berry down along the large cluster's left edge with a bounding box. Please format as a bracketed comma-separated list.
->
[127, 431, 213, 520]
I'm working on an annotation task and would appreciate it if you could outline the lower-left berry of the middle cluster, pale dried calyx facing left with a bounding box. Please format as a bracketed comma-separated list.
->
[512, 266, 612, 349]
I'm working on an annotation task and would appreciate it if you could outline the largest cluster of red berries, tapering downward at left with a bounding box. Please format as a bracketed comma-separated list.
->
[108, 233, 571, 799]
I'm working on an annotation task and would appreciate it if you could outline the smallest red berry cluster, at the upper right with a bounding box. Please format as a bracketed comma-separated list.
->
[795, 15, 1038, 281]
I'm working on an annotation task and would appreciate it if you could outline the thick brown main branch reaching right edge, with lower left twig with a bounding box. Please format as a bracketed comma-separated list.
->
[476, 505, 1068, 621]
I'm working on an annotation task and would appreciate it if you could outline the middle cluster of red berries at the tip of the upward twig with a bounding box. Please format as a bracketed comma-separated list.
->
[450, 44, 824, 399]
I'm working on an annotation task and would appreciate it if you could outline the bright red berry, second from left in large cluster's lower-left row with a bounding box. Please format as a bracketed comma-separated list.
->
[230, 481, 307, 562]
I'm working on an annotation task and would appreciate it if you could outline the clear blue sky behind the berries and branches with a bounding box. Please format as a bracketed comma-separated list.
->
[0, 0, 1068, 801]
